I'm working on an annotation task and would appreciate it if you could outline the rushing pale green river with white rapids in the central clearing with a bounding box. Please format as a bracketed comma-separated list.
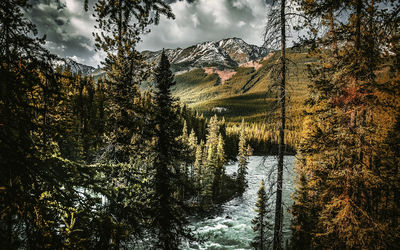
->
[184, 156, 294, 249]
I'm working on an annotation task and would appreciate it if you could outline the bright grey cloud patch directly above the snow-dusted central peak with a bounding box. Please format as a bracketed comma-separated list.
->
[139, 0, 267, 50]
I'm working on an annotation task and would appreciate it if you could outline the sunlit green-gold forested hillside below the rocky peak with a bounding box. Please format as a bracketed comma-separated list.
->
[173, 49, 310, 155]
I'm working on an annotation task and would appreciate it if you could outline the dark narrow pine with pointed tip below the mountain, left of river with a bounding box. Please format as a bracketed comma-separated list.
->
[153, 51, 192, 249]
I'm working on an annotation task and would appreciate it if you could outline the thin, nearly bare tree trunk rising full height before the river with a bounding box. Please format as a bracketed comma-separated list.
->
[273, 0, 286, 249]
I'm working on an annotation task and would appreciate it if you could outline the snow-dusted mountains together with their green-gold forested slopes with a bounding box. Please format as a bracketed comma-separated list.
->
[59, 38, 316, 154]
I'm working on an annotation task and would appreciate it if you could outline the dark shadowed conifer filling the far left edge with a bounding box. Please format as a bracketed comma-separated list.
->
[0, 1, 57, 245]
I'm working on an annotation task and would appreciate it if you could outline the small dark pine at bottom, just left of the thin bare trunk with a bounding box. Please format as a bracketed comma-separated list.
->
[251, 180, 273, 250]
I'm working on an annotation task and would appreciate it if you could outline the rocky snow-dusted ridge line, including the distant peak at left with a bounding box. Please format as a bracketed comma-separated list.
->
[55, 37, 269, 76]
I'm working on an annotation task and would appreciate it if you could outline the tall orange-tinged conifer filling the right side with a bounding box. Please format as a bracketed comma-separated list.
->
[293, 0, 400, 249]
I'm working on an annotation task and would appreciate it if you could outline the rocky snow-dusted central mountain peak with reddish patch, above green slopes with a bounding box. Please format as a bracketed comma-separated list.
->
[142, 37, 268, 72]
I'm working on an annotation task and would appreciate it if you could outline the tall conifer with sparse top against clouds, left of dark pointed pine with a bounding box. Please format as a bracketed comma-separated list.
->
[90, 0, 173, 162]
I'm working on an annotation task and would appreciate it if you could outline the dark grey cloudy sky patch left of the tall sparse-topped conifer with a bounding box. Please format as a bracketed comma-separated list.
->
[27, 0, 102, 66]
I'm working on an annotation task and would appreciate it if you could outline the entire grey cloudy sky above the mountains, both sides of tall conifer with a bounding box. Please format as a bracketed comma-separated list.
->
[28, 0, 266, 67]
